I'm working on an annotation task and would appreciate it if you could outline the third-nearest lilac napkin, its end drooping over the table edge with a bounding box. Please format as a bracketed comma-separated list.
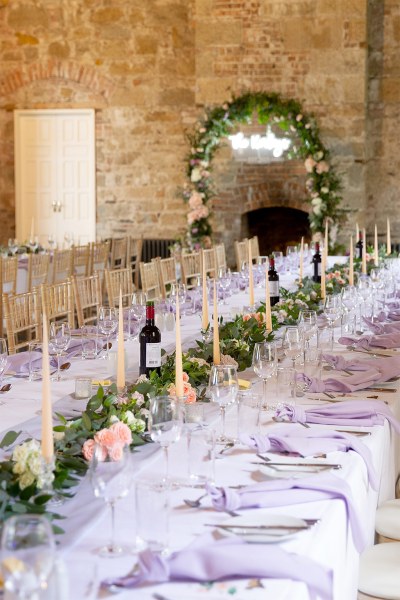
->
[240, 426, 379, 490]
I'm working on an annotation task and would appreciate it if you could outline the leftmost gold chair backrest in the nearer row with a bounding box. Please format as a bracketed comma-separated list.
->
[3, 289, 42, 354]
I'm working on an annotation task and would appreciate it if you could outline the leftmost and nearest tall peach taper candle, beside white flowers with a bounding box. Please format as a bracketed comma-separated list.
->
[42, 314, 54, 463]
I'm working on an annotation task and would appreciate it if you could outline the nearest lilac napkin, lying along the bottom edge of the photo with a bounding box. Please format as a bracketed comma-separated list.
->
[102, 533, 333, 600]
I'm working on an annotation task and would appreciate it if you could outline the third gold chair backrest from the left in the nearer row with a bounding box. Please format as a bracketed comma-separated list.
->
[72, 273, 102, 327]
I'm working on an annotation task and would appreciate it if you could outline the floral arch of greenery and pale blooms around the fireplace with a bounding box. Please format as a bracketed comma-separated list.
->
[182, 92, 347, 249]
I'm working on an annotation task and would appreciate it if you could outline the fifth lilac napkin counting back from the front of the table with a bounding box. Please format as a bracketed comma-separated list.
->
[296, 368, 380, 393]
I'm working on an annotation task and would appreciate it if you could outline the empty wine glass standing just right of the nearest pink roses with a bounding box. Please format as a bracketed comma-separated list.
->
[148, 396, 183, 483]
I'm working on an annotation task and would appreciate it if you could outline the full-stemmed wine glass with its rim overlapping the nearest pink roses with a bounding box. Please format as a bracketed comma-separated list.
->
[89, 444, 132, 558]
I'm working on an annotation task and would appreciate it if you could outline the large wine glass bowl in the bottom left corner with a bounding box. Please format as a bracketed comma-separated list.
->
[1, 514, 55, 600]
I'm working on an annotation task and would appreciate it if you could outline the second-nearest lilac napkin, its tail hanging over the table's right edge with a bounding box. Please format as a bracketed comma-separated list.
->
[206, 473, 367, 552]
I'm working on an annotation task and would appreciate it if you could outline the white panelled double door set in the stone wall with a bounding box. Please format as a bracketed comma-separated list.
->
[14, 109, 96, 248]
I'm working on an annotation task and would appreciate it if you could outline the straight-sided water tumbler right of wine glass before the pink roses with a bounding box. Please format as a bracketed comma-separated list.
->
[135, 481, 170, 554]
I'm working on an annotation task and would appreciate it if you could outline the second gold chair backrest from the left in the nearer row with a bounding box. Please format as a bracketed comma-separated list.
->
[40, 280, 75, 328]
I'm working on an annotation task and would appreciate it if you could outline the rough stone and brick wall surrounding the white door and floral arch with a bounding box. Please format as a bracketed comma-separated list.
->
[0, 0, 400, 248]
